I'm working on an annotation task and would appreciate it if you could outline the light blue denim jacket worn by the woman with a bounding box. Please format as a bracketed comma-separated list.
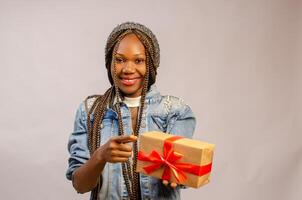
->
[66, 85, 195, 200]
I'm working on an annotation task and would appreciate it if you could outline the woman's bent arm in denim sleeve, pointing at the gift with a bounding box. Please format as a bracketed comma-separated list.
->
[66, 104, 137, 193]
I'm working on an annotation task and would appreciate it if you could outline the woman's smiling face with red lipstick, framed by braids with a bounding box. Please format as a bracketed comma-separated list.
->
[111, 34, 147, 97]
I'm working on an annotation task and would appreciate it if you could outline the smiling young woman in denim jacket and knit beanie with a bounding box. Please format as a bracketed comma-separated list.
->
[66, 22, 195, 200]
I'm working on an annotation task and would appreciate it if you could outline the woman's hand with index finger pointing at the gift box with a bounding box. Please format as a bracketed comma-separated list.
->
[94, 135, 137, 163]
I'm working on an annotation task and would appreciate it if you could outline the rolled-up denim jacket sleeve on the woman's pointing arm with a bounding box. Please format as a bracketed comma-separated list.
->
[66, 103, 90, 180]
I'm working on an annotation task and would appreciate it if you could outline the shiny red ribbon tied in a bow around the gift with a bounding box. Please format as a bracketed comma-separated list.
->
[137, 136, 212, 183]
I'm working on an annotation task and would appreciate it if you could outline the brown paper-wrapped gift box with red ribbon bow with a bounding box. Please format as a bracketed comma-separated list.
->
[136, 132, 215, 188]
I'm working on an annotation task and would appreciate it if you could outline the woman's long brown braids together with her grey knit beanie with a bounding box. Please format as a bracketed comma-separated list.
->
[86, 22, 160, 200]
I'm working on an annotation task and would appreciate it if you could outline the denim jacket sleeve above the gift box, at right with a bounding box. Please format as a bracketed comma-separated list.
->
[167, 97, 196, 138]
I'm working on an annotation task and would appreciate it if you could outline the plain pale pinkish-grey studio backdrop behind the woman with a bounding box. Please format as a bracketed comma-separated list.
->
[0, 0, 302, 200]
